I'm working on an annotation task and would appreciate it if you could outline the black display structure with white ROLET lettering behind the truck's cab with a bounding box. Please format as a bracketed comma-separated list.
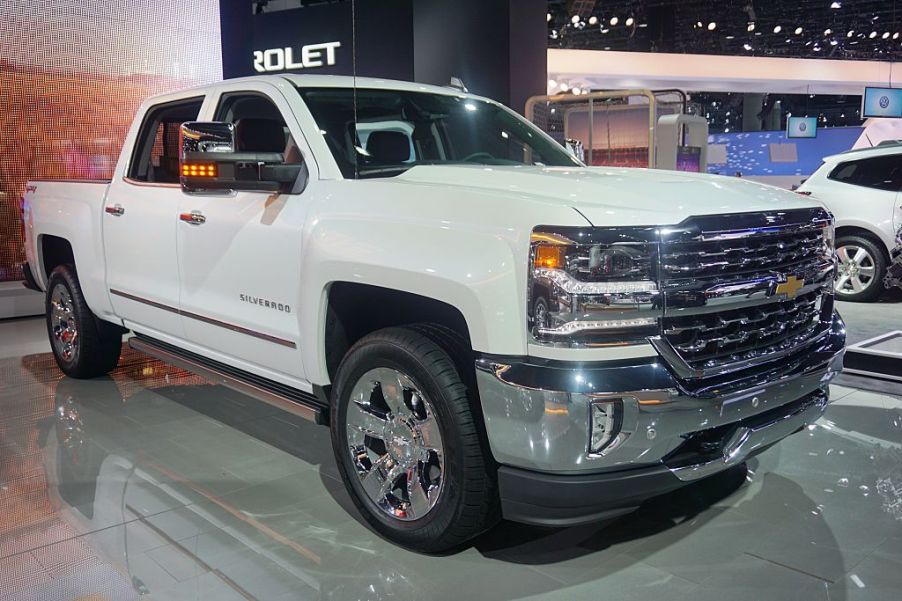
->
[219, 0, 548, 113]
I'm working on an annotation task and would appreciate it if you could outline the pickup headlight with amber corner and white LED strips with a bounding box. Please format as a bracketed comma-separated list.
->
[528, 227, 662, 346]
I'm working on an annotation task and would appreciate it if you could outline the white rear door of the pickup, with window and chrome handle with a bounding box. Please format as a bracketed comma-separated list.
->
[103, 95, 204, 338]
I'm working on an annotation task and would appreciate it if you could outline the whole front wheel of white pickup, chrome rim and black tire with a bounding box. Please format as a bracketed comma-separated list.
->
[331, 327, 497, 552]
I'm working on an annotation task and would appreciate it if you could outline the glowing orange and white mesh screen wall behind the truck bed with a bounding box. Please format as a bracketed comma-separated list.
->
[0, 0, 222, 281]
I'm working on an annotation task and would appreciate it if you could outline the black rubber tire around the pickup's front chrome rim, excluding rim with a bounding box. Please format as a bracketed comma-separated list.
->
[330, 324, 499, 553]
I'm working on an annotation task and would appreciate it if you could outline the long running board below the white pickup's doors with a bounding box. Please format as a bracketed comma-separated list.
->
[128, 335, 326, 424]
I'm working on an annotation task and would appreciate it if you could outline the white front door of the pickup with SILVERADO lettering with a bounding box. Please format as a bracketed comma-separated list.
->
[177, 83, 315, 384]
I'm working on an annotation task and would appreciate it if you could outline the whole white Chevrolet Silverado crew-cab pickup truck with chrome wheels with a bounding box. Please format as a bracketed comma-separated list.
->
[24, 75, 845, 551]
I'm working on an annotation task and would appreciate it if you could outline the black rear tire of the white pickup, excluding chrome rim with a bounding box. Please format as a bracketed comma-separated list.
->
[44, 265, 123, 379]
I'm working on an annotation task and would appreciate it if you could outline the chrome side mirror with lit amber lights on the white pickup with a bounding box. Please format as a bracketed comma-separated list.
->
[179, 121, 303, 193]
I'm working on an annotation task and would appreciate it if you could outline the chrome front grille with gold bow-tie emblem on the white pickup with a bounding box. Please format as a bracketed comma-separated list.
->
[656, 209, 833, 378]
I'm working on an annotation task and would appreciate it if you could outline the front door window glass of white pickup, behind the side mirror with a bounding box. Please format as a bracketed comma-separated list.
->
[214, 92, 301, 164]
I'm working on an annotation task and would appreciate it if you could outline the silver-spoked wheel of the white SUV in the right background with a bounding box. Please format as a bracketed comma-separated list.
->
[833, 236, 886, 302]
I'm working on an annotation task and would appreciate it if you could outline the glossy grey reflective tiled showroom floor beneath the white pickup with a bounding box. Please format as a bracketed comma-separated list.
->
[0, 320, 902, 601]
